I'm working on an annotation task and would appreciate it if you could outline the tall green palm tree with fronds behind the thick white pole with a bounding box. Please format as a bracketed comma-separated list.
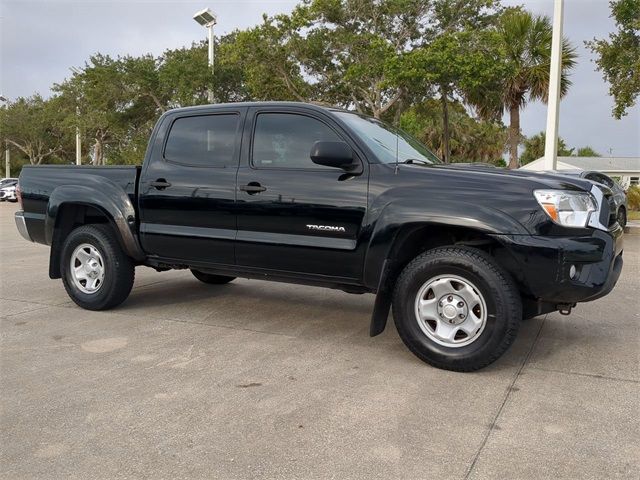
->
[470, 8, 577, 168]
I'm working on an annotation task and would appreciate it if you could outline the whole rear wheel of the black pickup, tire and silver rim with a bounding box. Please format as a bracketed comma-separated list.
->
[60, 224, 135, 310]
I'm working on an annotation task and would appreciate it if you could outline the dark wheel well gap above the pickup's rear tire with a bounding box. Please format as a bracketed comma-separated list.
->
[49, 203, 112, 278]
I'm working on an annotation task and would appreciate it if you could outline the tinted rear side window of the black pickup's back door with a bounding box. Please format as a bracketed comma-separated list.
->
[164, 114, 239, 167]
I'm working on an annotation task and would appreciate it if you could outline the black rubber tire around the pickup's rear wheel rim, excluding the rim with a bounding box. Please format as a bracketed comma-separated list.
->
[60, 224, 135, 310]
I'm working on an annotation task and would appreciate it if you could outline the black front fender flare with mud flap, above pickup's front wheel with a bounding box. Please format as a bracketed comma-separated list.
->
[363, 198, 529, 288]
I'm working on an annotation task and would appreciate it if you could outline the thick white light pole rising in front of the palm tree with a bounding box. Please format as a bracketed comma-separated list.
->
[544, 0, 564, 170]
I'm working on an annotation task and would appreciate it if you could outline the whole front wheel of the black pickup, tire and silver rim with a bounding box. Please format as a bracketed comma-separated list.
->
[393, 247, 522, 372]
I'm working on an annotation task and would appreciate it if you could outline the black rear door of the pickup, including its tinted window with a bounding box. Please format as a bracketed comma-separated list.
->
[139, 108, 246, 265]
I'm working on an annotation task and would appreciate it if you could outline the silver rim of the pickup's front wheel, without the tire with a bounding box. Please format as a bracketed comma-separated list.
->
[415, 275, 487, 348]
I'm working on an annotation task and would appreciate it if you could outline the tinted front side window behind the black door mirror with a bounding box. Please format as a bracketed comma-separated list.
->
[252, 113, 342, 168]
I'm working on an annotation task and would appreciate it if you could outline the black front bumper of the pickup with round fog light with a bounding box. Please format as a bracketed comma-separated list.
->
[496, 224, 623, 305]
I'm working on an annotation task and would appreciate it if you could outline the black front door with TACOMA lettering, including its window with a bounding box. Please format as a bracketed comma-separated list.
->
[236, 107, 369, 279]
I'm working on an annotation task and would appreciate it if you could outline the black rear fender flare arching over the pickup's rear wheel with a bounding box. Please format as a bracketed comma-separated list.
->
[45, 174, 145, 260]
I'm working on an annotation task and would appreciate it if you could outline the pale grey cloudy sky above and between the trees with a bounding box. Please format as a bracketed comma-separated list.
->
[0, 0, 640, 156]
